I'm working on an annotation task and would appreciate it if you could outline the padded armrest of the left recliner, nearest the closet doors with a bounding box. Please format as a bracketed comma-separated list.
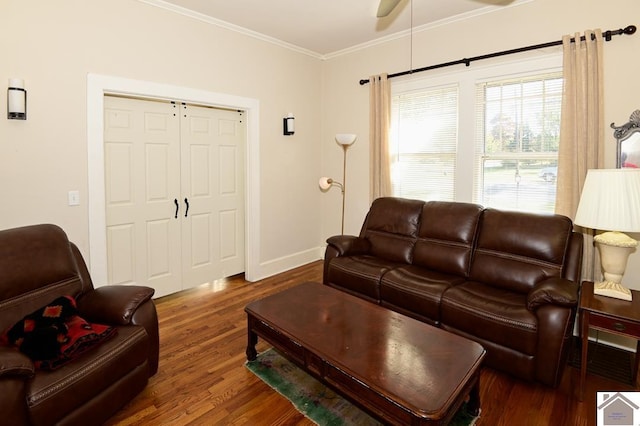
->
[78, 285, 155, 325]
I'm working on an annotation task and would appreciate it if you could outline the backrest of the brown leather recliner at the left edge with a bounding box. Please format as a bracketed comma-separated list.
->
[0, 225, 83, 333]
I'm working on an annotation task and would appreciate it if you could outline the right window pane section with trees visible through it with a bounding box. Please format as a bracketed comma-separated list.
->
[475, 74, 562, 213]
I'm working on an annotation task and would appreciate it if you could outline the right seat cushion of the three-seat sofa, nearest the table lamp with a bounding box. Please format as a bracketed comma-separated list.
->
[441, 281, 538, 355]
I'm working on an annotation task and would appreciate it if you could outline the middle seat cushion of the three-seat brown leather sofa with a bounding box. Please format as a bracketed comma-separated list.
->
[380, 265, 464, 325]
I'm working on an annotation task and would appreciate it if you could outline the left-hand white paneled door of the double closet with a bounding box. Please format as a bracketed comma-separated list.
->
[104, 96, 181, 296]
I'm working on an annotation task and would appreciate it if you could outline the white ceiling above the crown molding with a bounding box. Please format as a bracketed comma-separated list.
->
[146, 0, 533, 57]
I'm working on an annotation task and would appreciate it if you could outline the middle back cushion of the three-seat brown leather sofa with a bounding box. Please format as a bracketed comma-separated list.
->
[413, 201, 482, 277]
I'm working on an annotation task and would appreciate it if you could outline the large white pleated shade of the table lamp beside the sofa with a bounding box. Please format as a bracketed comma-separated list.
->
[574, 168, 640, 232]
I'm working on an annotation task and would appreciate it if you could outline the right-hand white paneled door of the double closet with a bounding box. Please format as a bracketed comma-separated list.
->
[180, 105, 246, 288]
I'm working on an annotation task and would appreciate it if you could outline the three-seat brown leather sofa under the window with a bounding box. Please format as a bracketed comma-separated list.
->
[323, 198, 583, 387]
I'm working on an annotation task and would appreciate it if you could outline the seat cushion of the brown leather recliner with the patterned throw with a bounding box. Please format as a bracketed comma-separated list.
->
[27, 326, 149, 424]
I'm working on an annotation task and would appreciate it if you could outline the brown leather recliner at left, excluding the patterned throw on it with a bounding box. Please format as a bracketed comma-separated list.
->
[0, 225, 159, 426]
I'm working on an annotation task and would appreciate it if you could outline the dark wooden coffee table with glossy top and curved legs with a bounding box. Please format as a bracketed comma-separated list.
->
[245, 283, 485, 425]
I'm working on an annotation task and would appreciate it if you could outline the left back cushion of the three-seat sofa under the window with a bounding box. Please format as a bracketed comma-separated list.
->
[360, 197, 424, 263]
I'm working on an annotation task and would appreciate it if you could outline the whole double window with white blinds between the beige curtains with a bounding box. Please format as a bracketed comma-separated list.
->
[390, 55, 562, 213]
